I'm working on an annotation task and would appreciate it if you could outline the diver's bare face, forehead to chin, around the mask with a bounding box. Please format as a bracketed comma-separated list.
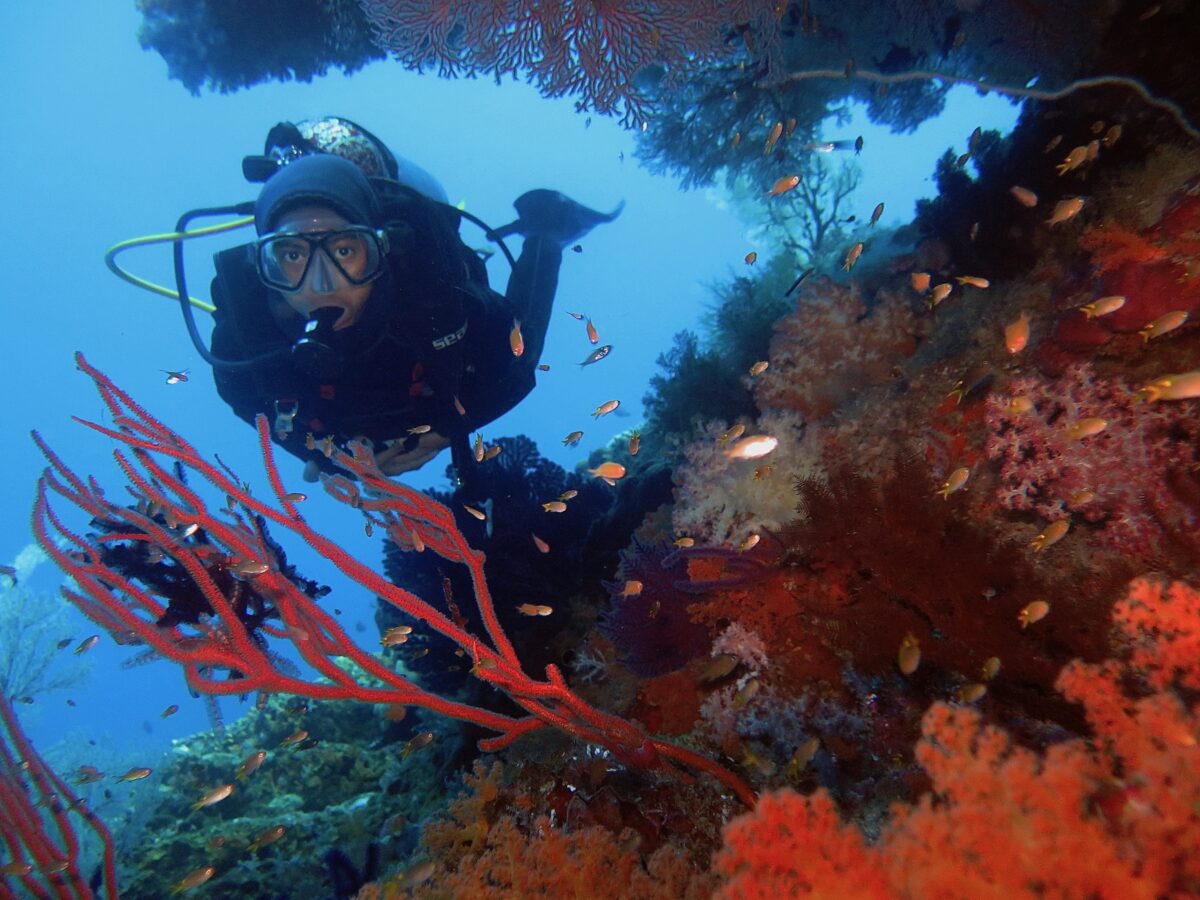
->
[268, 206, 374, 331]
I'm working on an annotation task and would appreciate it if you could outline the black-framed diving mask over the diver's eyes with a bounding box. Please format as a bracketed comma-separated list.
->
[256, 226, 388, 294]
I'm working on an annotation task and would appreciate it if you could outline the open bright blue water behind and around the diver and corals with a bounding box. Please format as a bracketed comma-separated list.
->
[0, 0, 1016, 766]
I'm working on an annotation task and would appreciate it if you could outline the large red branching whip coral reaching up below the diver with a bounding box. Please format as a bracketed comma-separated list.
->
[34, 356, 752, 803]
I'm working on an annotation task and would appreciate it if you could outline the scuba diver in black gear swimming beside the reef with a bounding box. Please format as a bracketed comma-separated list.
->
[204, 116, 622, 486]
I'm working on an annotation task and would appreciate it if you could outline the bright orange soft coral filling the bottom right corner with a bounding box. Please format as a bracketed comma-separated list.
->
[715, 580, 1200, 899]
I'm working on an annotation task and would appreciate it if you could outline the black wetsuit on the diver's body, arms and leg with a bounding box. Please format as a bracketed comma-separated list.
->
[212, 183, 562, 480]
